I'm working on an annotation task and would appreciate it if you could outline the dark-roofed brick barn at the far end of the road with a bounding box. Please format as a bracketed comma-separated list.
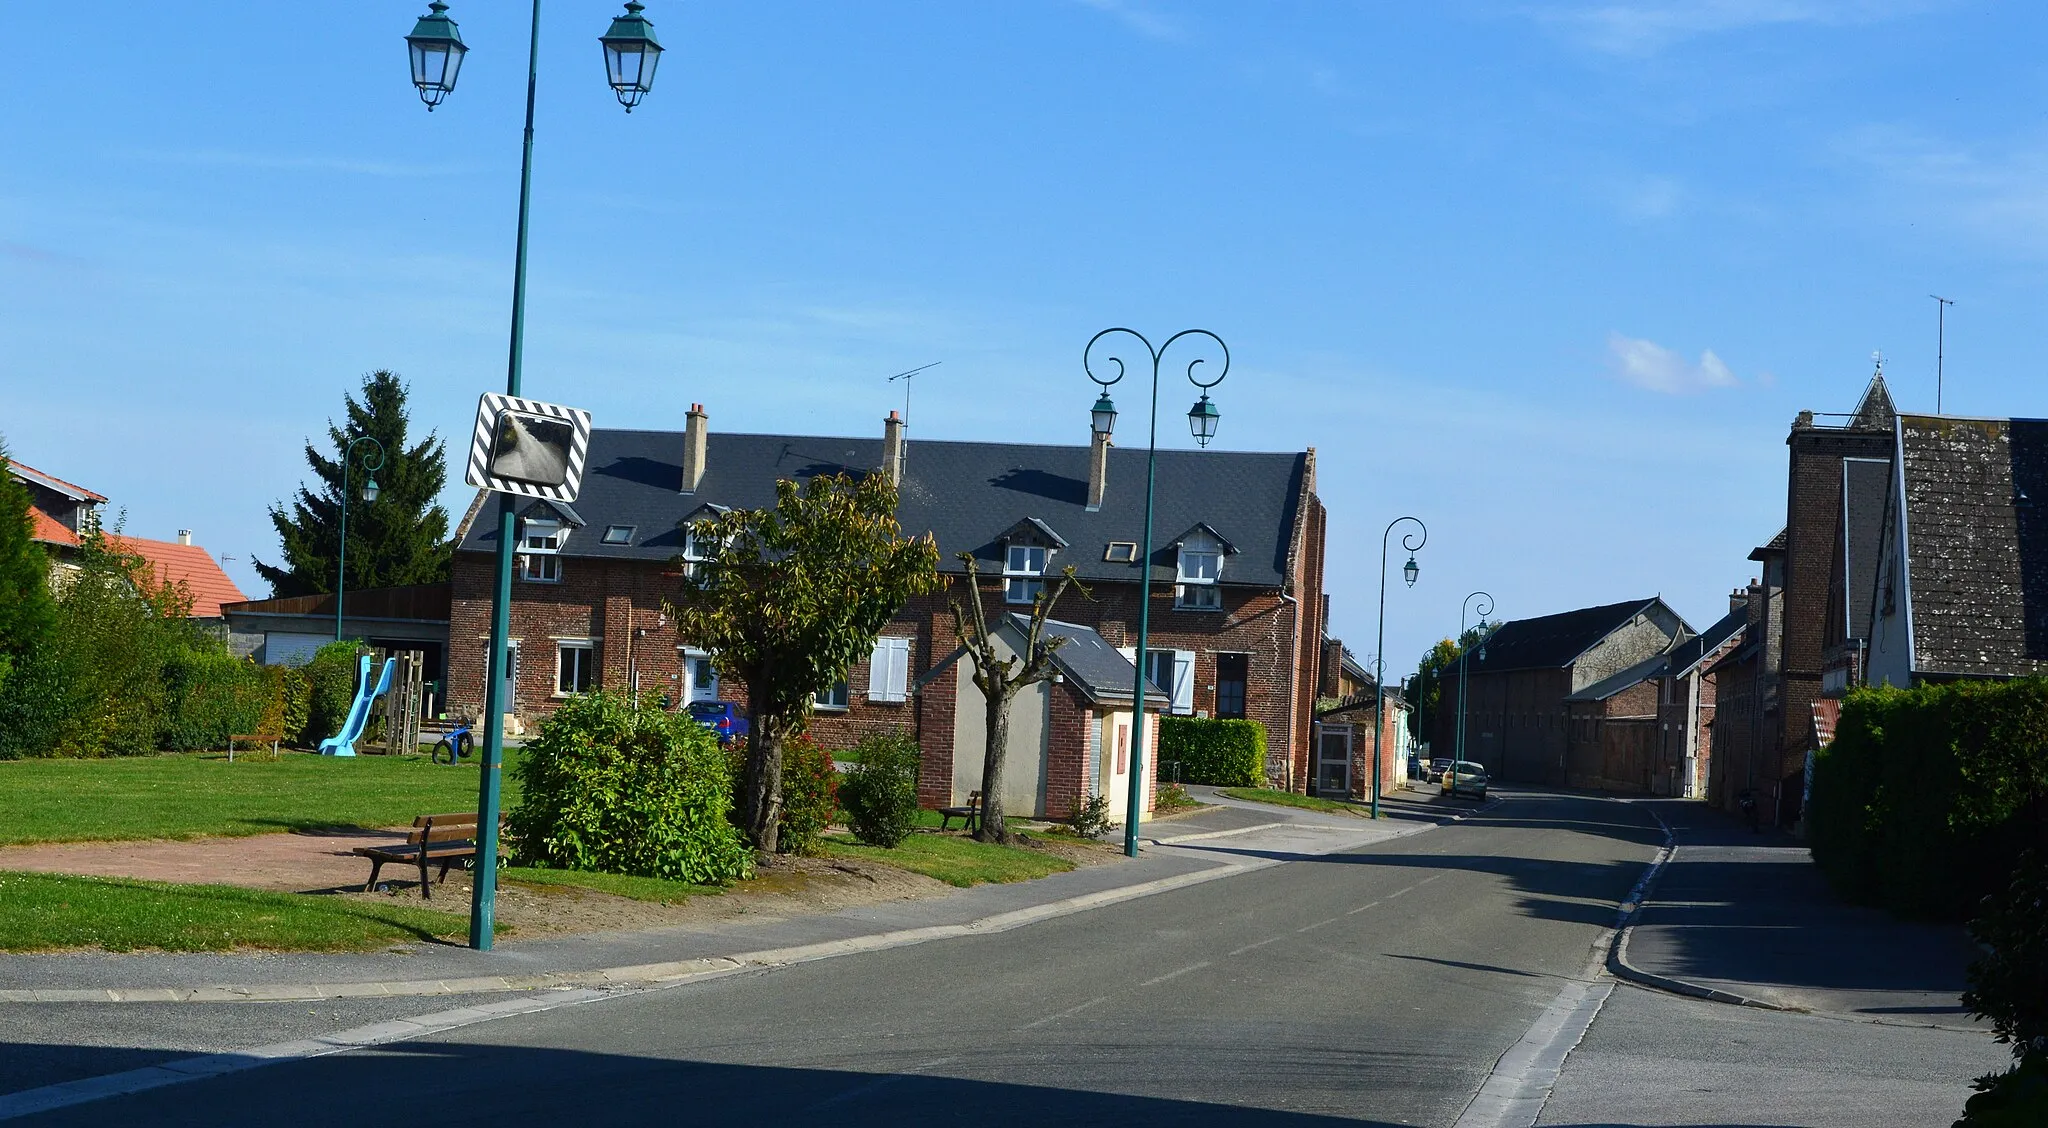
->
[1430, 598, 1694, 784]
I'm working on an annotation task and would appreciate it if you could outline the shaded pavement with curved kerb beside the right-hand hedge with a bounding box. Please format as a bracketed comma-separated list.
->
[1616, 800, 1989, 1030]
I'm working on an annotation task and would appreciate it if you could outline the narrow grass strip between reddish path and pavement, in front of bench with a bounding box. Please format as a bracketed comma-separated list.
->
[0, 872, 469, 952]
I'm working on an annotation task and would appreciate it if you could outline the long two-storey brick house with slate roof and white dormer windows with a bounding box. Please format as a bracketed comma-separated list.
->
[449, 405, 1327, 815]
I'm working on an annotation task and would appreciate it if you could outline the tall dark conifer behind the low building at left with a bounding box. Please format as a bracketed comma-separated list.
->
[254, 368, 453, 596]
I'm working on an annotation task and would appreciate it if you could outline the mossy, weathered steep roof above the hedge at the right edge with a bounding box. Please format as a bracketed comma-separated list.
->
[1898, 416, 2048, 678]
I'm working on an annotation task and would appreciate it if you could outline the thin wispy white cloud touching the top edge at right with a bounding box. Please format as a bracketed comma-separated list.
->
[1524, 0, 1935, 55]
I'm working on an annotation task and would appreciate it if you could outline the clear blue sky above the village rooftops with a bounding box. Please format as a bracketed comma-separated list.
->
[0, 0, 2048, 669]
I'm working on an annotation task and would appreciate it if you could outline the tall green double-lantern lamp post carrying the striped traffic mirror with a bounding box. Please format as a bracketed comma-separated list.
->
[406, 0, 662, 952]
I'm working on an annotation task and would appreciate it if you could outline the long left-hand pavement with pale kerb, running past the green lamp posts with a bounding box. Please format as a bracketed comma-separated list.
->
[0, 807, 1436, 1003]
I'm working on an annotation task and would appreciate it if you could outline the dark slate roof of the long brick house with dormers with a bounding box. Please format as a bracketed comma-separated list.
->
[461, 430, 1309, 588]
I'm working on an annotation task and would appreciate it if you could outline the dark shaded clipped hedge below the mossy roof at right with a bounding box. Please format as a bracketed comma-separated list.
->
[1806, 678, 2048, 919]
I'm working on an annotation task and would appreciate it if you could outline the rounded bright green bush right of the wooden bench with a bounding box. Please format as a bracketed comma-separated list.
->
[510, 692, 754, 884]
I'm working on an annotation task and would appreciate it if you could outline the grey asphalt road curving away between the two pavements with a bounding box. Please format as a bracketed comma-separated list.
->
[8, 796, 1661, 1128]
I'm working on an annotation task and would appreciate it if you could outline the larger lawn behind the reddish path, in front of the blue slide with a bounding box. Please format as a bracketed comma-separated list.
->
[0, 749, 518, 845]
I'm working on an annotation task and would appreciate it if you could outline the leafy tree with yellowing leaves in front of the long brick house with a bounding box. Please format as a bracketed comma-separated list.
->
[674, 475, 938, 854]
